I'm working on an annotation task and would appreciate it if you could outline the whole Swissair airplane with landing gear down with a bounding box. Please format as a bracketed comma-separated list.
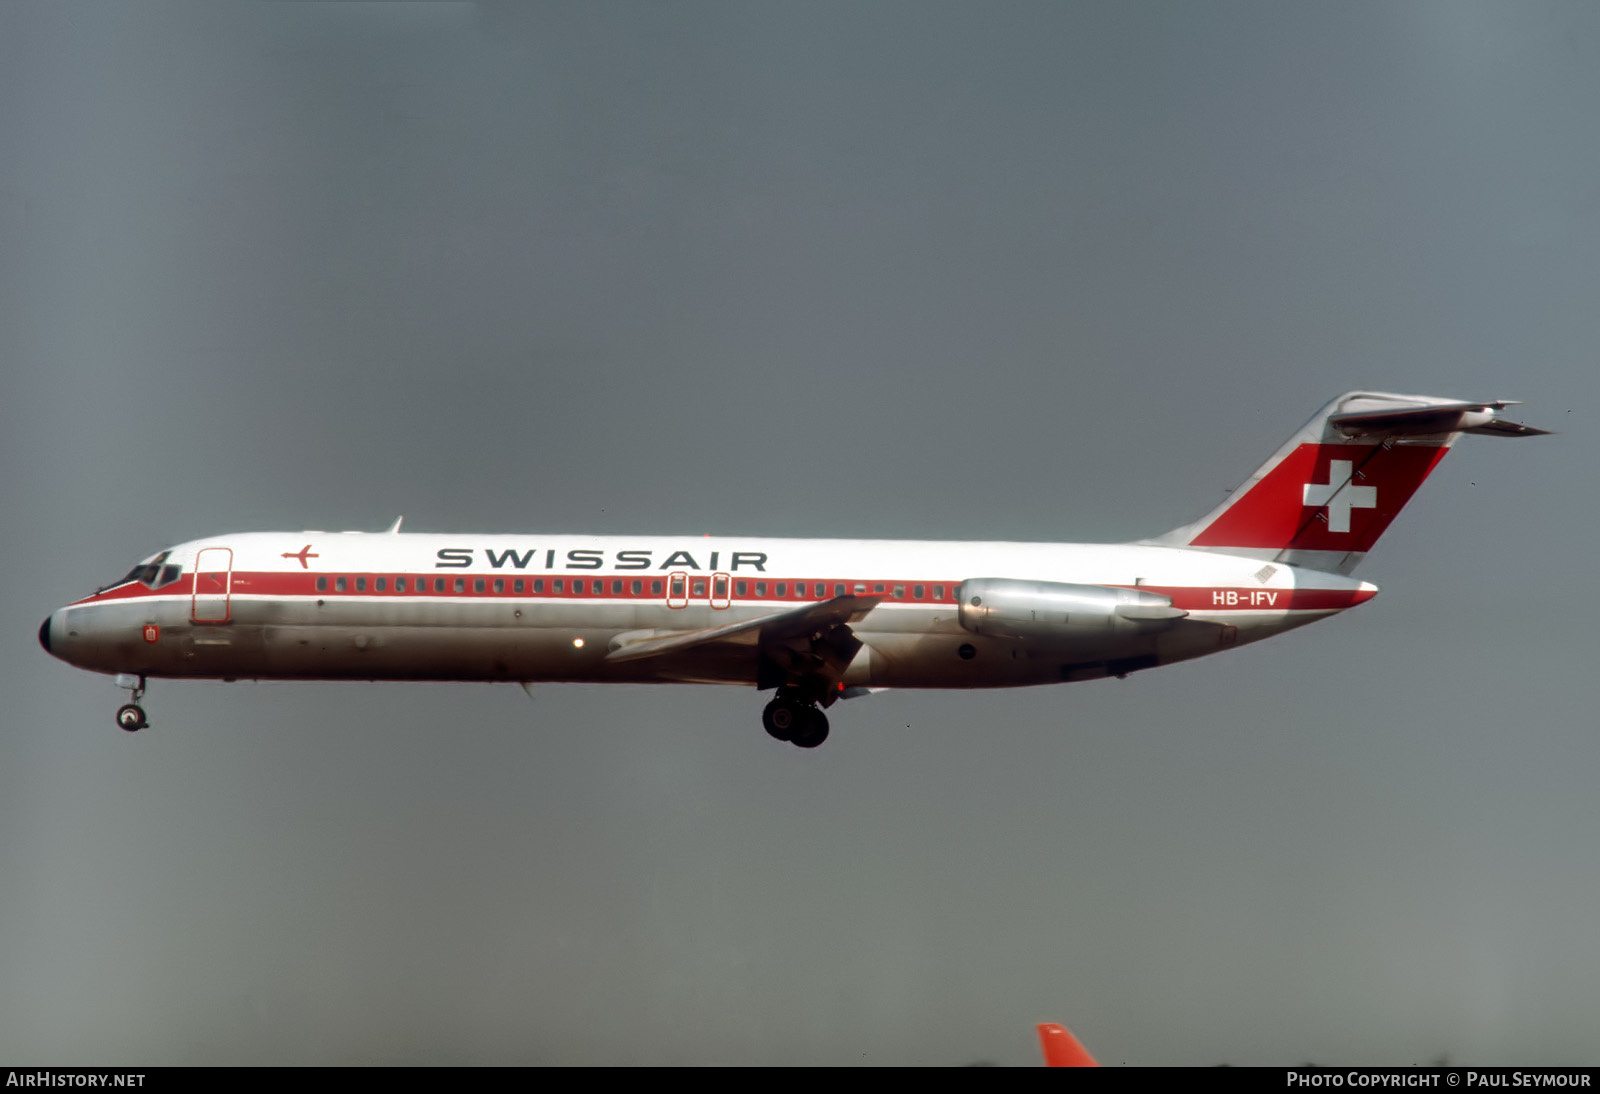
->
[38, 392, 1549, 749]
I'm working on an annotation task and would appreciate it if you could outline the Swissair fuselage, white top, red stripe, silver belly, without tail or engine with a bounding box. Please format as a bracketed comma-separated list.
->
[40, 533, 1376, 688]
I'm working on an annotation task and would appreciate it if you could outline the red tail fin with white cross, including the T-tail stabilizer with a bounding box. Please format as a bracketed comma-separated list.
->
[1146, 392, 1547, 574]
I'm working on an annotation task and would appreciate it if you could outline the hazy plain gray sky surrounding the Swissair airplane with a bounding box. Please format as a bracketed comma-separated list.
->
[0, 0, 1600, 1064]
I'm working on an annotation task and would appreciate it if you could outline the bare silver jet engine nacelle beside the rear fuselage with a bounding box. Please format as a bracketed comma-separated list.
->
[960, 577, 1189, 640]
